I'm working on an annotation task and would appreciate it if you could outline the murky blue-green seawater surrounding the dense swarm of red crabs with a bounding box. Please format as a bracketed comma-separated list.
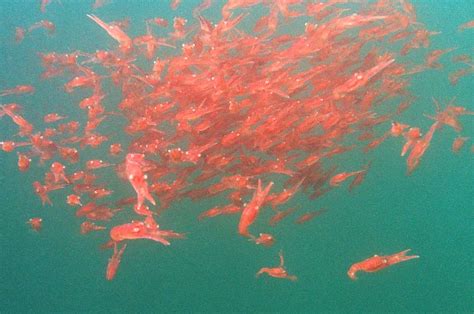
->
[0, 0, 474, 313]
